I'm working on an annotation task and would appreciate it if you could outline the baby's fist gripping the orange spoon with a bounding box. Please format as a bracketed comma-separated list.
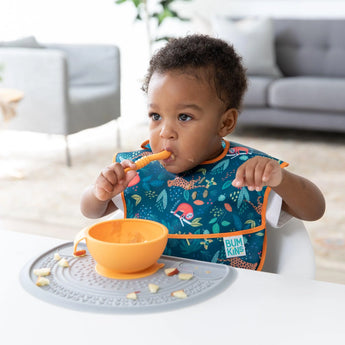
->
[93, 160, 137, 201]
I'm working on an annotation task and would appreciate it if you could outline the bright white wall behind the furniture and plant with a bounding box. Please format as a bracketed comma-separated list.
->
[0, 0, 345, 122]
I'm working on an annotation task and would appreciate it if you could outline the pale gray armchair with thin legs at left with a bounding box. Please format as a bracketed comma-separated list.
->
[0, 37, 121, 165]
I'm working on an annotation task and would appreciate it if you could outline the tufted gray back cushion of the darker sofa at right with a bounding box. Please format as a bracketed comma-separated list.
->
[273, 19, 345, 77]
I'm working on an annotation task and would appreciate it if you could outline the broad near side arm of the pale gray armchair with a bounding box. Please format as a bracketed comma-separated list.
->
[0, 48, 69, 134]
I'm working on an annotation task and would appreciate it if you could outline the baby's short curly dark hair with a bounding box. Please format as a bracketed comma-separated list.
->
[142, 34, 247, 110]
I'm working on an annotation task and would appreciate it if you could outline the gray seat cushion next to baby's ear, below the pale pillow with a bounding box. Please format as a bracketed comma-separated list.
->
[243, 76, 274, 107]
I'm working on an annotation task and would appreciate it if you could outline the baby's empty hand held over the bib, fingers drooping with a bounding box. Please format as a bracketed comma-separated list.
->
[232, 156, 283, 191]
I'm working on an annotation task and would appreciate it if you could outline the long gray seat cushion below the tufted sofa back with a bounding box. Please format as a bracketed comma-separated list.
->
[268, 77, 345, 112]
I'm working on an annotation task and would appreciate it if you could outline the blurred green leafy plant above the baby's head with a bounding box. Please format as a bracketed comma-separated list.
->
[115, 0, 192, 51]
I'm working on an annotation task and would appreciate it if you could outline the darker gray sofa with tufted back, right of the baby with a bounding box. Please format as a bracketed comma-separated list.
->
[239, 19, 345, 132]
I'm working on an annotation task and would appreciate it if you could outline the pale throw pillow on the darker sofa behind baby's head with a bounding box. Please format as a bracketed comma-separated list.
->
[212, 16, 281, 77]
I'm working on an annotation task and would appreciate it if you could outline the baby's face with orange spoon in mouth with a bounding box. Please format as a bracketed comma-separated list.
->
[148, 72, 225, 174]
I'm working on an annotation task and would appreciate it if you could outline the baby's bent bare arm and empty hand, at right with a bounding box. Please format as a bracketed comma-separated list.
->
[232, 156, 325, 221]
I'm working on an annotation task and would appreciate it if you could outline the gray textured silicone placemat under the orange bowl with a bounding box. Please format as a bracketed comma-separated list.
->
[20, 242, 235, 313]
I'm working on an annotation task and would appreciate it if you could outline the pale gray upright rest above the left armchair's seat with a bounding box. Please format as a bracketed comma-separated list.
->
[45, 44, 120, 89]
